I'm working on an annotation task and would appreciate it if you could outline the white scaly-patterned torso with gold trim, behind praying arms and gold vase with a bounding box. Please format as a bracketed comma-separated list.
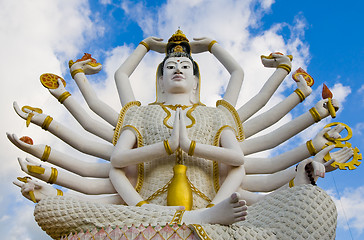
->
[114, 100, 245, 209]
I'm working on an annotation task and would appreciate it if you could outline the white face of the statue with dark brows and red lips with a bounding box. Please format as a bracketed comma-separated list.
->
[161, 57, 198, 93]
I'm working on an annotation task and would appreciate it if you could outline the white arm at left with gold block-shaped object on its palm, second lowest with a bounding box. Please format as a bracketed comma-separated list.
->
[18, 158, 116, 195]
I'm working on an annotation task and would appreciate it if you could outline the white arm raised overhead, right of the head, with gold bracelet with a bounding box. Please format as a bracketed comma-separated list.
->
[191, 38, 244, 106]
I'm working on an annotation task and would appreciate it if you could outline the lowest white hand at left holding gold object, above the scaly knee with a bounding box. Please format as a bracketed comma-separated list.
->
[13, 177, 57, 202]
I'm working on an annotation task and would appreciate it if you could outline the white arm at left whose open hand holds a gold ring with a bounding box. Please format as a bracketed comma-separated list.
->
[14, 102, 113, 160]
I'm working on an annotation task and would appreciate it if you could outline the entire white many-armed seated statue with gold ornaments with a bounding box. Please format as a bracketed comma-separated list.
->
[7, 30, 361, 239]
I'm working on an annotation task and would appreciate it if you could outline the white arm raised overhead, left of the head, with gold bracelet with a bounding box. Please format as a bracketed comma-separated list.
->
[114, 37, 165, 106]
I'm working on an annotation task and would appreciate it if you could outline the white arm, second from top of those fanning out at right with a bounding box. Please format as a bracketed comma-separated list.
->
[243, 76, 312, 138]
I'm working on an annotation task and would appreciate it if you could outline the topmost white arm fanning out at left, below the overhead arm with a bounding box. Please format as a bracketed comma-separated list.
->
[70, 60, 119, 126]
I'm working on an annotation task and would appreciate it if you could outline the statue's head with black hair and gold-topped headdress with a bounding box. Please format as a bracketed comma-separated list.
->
[156, 30, 200, 103]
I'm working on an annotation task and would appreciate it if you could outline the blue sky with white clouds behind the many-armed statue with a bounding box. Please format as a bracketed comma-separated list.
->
[0, 0, 364, 240]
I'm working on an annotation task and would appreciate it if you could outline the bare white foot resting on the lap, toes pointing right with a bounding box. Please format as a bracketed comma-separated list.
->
[183, 193, 248, 225]
